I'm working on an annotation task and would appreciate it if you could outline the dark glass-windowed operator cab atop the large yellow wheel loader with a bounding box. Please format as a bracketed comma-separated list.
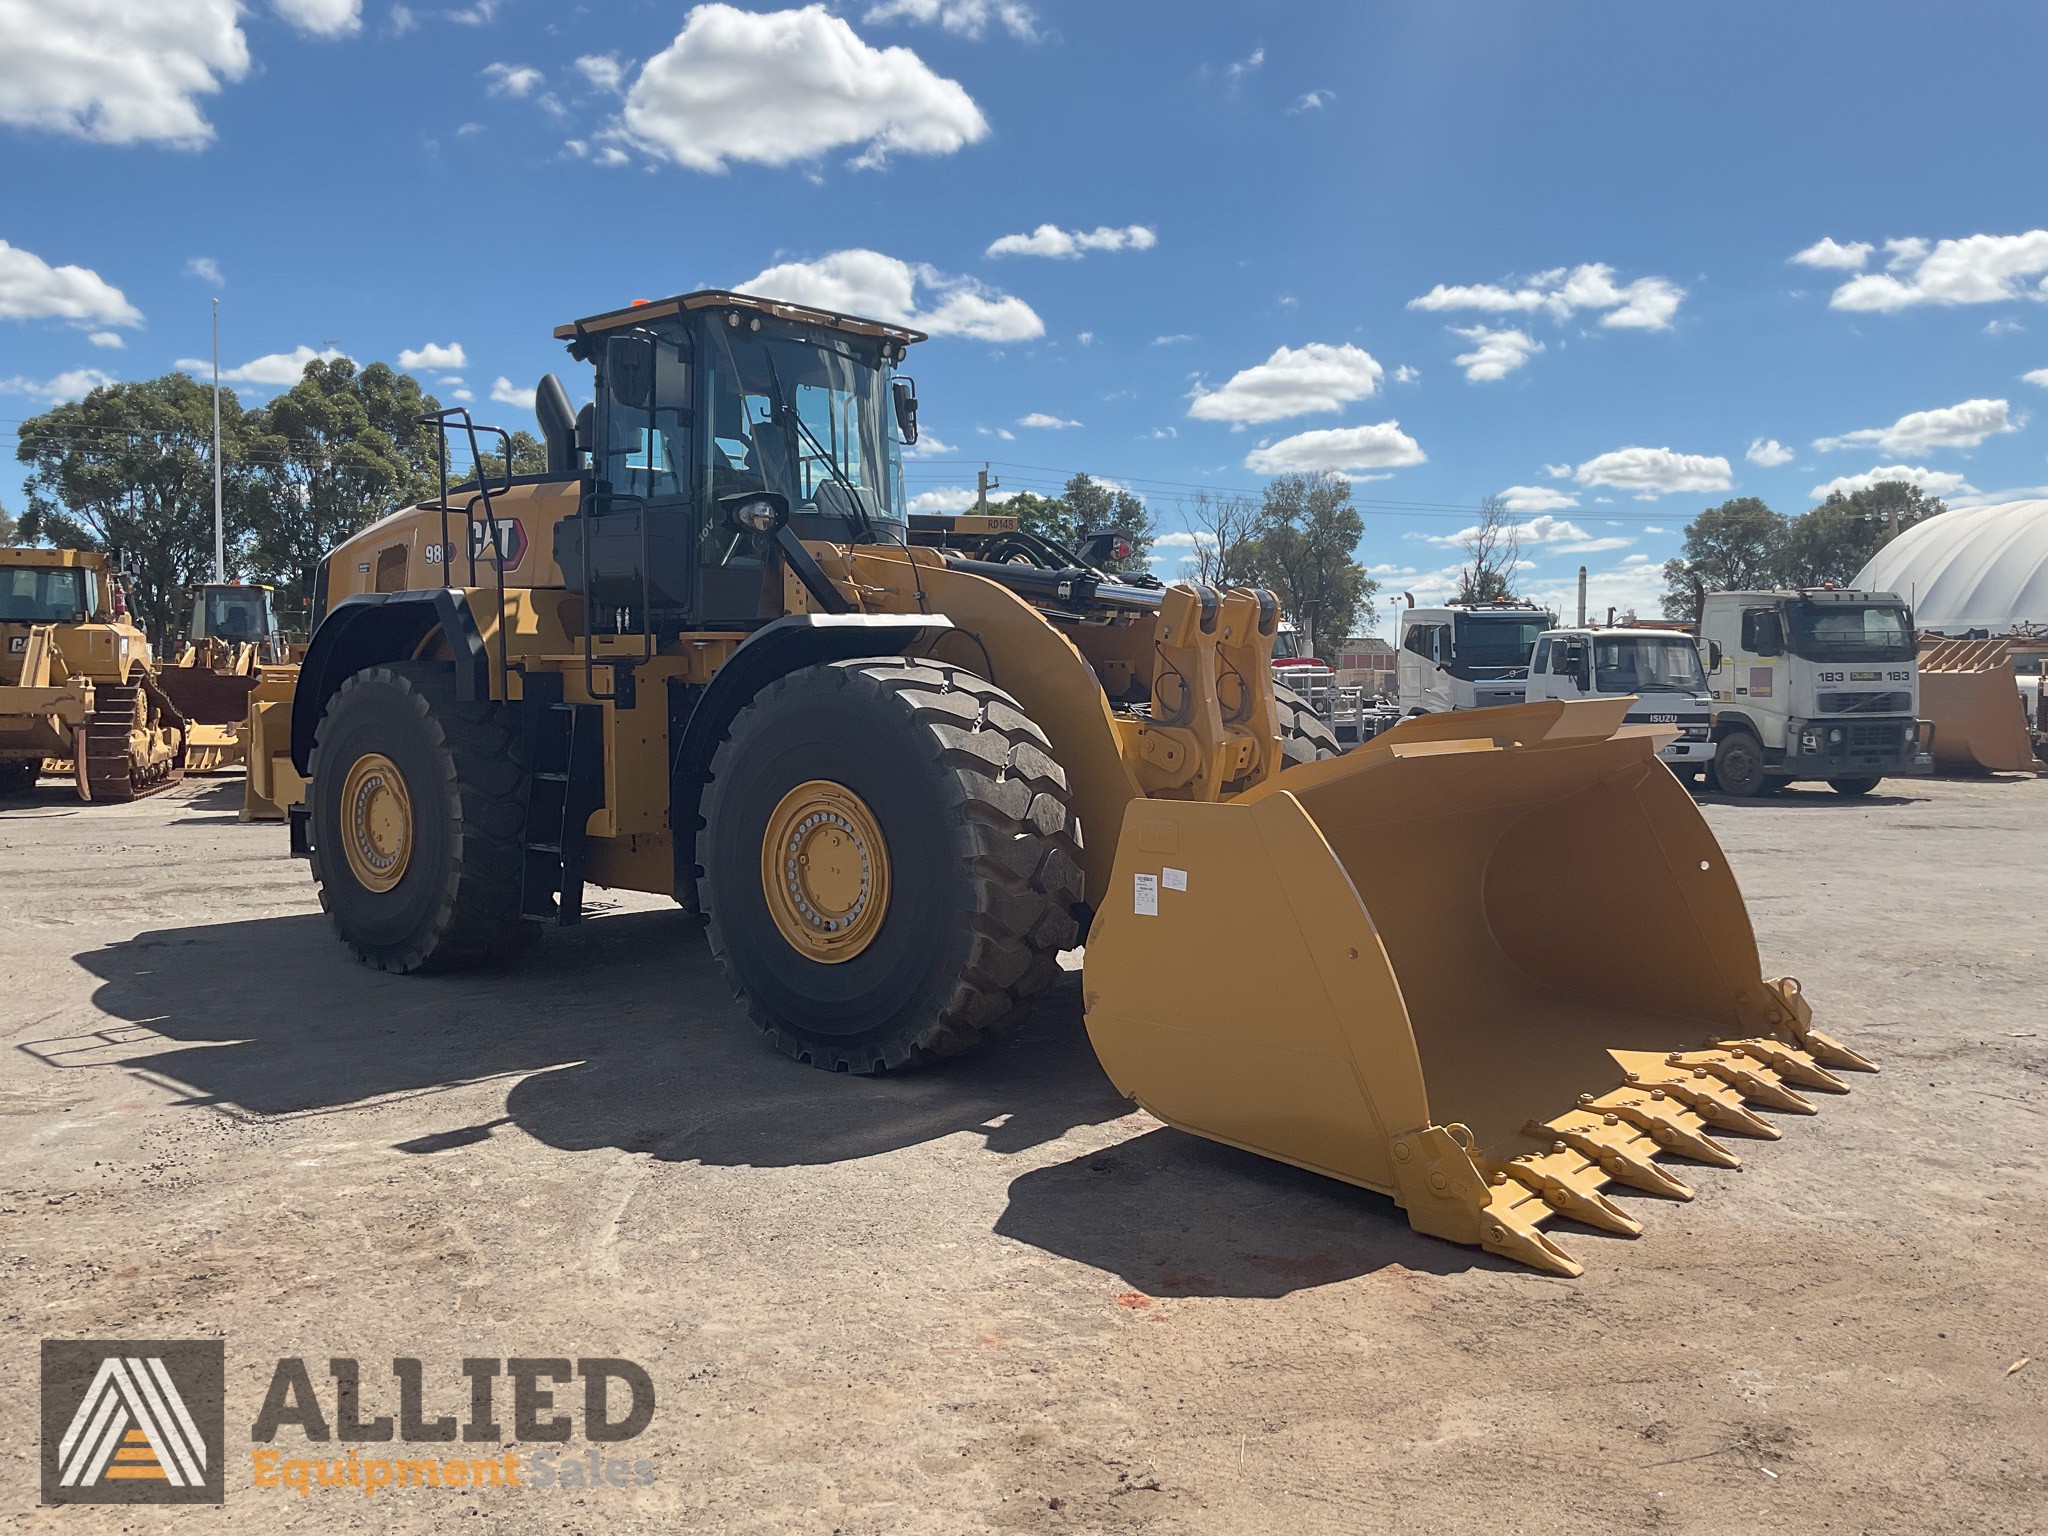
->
[555, 293, 924, 637]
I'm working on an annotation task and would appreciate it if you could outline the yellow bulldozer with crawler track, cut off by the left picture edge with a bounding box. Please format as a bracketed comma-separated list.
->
[0, 549, 186, 801]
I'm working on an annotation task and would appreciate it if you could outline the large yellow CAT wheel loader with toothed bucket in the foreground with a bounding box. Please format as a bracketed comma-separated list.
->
[268, 293, 1868, 1274]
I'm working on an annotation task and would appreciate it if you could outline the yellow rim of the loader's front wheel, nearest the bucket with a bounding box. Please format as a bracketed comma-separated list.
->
[762, 778, 889, 965]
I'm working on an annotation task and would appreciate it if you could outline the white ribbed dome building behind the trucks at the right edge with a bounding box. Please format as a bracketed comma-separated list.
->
[1855, 502, 2048, 635]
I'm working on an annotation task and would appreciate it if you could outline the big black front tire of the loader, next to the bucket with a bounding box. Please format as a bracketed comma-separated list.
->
[696, 657, 1081, 1073]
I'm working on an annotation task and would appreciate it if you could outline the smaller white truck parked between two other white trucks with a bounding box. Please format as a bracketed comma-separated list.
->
[1526, 627, 1714, 780]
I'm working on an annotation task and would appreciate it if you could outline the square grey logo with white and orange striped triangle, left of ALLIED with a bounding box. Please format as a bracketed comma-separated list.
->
[43, 1339, 225, 1503]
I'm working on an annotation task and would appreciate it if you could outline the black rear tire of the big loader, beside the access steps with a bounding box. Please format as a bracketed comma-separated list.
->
[309, 662, 541, 973]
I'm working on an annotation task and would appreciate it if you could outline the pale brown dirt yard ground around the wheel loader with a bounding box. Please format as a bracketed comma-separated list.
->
[0, 780, 2048, 1536]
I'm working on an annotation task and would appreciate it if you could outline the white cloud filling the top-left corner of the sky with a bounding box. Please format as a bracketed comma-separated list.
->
[0, 0, 250, 150]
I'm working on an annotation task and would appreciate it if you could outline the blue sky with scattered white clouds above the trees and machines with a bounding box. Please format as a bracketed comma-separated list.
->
[0, 0, 2048, 626]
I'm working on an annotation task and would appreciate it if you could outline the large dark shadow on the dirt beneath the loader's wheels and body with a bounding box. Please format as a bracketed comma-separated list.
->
[59, 911, 1130, 1167]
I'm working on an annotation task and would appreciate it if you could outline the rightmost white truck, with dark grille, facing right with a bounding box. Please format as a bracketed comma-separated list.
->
[1700, 588, 1933, 797]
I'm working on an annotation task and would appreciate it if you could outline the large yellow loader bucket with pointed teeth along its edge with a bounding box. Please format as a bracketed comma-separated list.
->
[1083, 700, 1870, 1274]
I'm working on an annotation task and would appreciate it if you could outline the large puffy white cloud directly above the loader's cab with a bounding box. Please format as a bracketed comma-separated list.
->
[621, 4, 989, 172]
